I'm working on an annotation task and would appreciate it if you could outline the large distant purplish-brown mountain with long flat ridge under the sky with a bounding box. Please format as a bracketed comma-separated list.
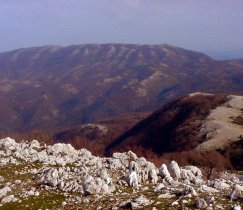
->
[0, 44, 243, 133]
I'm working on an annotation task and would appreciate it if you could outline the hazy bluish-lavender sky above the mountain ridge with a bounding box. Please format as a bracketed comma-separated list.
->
[0, 0, 243, 58]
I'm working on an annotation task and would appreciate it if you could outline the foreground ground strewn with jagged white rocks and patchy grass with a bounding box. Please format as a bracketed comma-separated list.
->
[0, 138, 243, 210]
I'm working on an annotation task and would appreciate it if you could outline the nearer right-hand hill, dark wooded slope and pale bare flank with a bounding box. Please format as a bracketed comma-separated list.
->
[106, 93, 243, 168]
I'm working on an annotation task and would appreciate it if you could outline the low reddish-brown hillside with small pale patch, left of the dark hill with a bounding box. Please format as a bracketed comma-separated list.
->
[53, 112, 150, 148]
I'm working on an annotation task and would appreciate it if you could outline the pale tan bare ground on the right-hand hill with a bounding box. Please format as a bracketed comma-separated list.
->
[196, 93, 243, 151]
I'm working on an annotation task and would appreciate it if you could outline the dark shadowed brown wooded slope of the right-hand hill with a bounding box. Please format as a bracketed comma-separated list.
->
[106, 94, 228, 154]
